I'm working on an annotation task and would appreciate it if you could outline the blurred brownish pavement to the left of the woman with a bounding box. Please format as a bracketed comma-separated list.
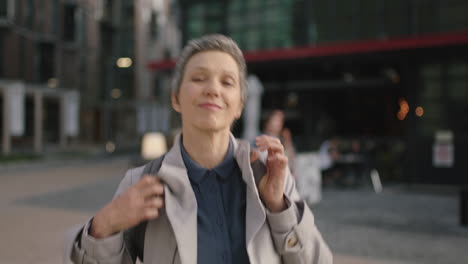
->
[0, 159, 128, 264]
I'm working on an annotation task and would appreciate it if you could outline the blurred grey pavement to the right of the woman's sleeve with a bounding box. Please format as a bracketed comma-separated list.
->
[313, 186, 468, 264]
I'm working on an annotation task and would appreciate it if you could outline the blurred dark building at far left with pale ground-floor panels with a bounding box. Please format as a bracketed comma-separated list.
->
[0, 0, 102, 154]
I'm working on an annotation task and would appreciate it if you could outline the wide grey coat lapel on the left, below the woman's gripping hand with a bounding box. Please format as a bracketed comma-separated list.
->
[145, 136, 197, 264]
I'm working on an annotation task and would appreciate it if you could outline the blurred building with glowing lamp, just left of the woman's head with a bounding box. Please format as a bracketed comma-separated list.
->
[96, 0, 181, 149]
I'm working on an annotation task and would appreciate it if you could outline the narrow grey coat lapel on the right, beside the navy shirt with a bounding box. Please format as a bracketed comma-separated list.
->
[231, 135, 266, 249]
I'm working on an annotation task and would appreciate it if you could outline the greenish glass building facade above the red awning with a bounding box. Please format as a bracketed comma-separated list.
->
[180, 0, 468, 51]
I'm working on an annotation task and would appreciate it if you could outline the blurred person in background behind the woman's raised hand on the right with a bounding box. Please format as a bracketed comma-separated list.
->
[263, 109, 296, 176]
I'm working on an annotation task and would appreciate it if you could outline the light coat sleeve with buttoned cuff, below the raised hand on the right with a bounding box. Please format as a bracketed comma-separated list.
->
[267, 170, 333, 264]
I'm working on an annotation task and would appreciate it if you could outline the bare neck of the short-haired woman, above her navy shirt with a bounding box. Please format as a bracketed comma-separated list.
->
[182, 128, 230, 169]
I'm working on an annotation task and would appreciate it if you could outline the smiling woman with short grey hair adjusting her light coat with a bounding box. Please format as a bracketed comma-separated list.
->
[67, 35, 332, 264]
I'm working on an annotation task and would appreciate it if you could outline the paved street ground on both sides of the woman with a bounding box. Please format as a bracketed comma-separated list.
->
[0, 158, 468, 264]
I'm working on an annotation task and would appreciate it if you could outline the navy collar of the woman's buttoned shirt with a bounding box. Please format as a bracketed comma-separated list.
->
[180, 136, 236, 183]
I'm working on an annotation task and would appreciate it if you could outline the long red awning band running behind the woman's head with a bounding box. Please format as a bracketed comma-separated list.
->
[147, 31, 468, 71]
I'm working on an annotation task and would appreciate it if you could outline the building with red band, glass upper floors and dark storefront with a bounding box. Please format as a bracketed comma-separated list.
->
[148, 0, 468, 184]
